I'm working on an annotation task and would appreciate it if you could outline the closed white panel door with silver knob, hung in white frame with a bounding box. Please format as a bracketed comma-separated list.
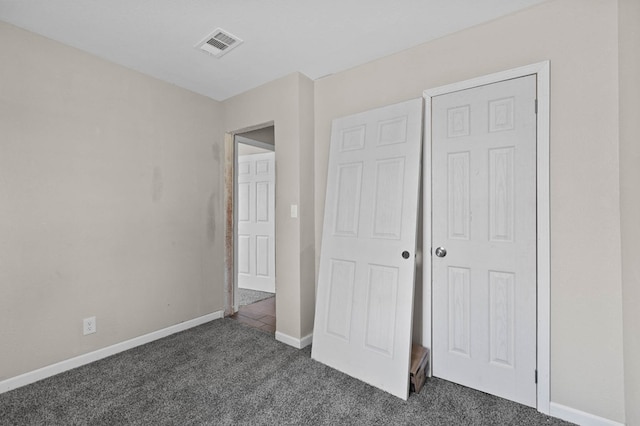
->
[432, 76, 537, 407]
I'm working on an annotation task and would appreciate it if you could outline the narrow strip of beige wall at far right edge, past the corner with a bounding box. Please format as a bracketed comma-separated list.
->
[619, 0, 640, 425]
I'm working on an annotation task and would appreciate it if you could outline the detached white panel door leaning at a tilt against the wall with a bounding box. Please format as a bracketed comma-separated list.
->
[311, 99, 422, 399]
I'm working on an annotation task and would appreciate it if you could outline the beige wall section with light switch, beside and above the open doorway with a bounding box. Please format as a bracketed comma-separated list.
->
[223, 73, 315, 339]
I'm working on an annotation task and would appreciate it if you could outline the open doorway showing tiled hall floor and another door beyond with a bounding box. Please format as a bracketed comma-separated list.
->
[227, 125, 276, 334]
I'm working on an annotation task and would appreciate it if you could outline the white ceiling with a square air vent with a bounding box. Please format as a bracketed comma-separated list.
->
[0, 0, 544, 100]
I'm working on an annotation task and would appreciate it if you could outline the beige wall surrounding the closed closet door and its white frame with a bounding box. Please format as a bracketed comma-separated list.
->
[315, 0, 625, 422]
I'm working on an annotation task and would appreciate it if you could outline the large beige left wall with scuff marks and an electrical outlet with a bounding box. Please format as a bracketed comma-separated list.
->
[0, 22, 224, 380]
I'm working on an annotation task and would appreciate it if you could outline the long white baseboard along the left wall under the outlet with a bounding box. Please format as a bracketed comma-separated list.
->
[0, 311, 224, 394]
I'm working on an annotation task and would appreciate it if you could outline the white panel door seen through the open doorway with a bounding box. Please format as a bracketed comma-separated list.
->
[236, 152, 276, 293]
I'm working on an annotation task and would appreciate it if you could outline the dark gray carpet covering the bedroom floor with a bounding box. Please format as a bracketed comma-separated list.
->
[0, 319, 567, 425]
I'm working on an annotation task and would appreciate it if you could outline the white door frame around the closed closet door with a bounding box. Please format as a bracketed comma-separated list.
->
[422, 61, 551, 414]
